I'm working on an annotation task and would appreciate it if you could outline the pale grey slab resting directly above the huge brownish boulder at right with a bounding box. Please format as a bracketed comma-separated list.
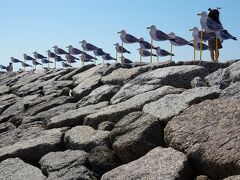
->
[143, 87, 221, 124]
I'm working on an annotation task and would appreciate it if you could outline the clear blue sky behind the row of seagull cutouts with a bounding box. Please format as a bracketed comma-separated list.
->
[0, 0, 240, 68]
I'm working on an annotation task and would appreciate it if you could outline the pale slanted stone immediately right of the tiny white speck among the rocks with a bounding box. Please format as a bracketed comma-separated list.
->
[73, 75, 101, 99]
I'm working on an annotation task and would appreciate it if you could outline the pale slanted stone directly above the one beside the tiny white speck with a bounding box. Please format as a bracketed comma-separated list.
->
[72, 65, 102, 85]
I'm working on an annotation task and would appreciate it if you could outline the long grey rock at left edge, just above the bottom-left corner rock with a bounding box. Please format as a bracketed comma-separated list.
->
[0, 129, 65, 164]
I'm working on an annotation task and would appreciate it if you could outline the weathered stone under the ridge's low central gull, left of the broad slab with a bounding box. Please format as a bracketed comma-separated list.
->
[101, 67, 147, 85]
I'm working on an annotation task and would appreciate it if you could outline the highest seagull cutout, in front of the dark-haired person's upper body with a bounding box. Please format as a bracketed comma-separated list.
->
[197, 11, 223, 32]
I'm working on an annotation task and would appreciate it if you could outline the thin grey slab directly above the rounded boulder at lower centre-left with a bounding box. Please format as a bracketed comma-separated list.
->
[47, 102, 108, 128]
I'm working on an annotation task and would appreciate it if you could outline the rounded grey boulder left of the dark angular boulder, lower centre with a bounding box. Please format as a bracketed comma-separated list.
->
[64, 126, 110, 152]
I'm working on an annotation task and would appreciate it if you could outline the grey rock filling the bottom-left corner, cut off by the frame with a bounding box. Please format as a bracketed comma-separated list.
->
[0, 158, 47, 180]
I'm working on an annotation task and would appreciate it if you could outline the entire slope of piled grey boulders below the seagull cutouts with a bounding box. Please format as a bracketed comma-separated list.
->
[0, 61, 240, 180]
